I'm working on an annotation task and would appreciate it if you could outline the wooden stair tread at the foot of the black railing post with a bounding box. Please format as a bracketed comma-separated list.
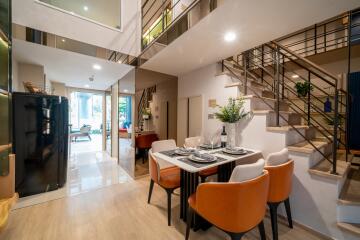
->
[309, 159, 350, 179]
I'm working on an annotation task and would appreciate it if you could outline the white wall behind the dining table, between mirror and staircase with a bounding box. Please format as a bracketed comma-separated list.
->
[178, 63, 238, 142]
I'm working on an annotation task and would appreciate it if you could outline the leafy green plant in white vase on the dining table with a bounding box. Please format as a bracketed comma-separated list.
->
[215, 98, 249, 148]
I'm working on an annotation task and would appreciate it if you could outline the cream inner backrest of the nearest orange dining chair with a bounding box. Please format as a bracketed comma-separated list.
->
[229, 158, 265, 182]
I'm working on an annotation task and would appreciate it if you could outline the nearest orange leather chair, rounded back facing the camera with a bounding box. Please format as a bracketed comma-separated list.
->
[185, 170, 269, 240]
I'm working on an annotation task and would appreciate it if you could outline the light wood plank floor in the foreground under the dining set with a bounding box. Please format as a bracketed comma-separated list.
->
[0, 178, 328, 240]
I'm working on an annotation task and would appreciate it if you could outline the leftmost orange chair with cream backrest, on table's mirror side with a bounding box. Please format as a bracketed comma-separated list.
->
[148, 140, 180, 226]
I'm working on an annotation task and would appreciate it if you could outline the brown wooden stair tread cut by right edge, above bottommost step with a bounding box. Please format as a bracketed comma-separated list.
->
[339, 168, 360, 206]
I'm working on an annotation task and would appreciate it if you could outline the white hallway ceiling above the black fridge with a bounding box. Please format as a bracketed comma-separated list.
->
[13, 39, 135, 92]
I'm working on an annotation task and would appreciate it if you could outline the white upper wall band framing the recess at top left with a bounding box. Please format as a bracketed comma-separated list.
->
[13, 0, 141, 56]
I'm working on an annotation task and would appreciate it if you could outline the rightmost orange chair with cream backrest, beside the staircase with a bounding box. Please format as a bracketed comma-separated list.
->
[265, 149, 294, 240]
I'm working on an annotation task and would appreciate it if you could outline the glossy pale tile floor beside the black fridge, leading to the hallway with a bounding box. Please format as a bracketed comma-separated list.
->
[15, 138, 131, 208]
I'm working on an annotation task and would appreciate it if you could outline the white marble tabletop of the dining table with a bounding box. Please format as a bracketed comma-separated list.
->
[153, 148, 261, 173]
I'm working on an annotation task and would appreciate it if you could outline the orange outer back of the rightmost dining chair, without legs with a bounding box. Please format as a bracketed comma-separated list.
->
[265, 160, 294, 203]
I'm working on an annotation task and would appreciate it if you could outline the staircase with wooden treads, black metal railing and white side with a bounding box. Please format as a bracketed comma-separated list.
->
[221, 42, 360, 239]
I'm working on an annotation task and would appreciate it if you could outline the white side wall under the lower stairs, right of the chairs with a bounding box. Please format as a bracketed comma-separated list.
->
[282, 152, 359, 240]
